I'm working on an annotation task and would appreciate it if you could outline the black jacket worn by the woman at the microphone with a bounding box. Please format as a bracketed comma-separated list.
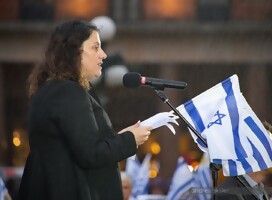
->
[19, 80, 137, 200]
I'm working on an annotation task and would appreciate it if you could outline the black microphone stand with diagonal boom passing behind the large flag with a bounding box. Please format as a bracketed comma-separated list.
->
[153, 88, 259, 200]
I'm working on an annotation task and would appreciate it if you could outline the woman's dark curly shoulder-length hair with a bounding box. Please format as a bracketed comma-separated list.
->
[28, 20, 99, 97]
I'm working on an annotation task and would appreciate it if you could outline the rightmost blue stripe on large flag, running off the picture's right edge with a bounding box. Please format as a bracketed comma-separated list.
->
[244, 117, 272, 160]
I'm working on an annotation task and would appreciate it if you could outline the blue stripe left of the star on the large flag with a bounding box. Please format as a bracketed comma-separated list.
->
[184, 100, 207, 148]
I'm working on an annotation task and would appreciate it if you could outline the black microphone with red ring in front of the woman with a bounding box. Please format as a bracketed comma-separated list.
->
[123, 72, 187, 89]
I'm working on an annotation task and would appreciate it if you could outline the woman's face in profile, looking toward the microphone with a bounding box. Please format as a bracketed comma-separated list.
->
[81, 31, 107, 80]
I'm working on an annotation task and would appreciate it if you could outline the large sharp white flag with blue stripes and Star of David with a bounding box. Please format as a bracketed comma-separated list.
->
[175, 75, 272, 176]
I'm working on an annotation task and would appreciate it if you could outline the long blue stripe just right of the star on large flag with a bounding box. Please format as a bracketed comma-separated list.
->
[222, 79, 247, 159]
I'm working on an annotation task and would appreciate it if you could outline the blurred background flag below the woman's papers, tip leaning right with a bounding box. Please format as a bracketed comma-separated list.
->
[131, 154, 152, 198]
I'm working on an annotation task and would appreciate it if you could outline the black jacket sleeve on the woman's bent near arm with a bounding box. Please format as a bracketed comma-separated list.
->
[52, 81, 137, 168]
